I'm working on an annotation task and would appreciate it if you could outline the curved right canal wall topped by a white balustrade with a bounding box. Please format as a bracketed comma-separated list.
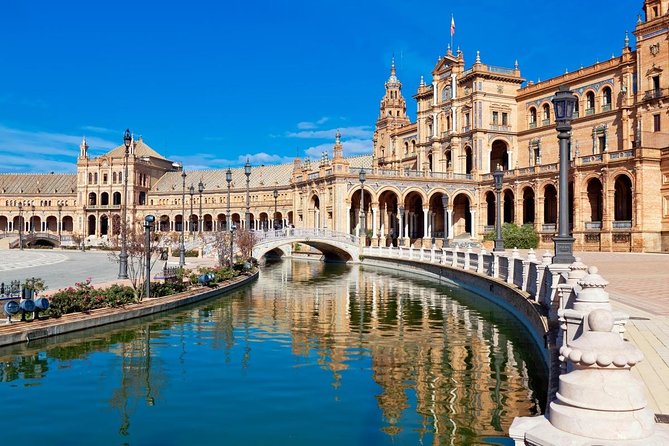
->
[362, 248, 557, 370]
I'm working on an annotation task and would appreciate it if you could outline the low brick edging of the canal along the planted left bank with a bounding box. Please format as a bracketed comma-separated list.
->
[0, 271, 259, 347]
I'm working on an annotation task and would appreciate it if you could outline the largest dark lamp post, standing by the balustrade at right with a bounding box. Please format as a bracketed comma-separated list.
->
[553, 85, 578, 264]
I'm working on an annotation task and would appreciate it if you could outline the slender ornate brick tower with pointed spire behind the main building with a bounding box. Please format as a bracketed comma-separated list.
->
[374, 57, 411, 163]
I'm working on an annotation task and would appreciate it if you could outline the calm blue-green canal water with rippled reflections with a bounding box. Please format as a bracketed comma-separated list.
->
[0, 261, 545, 445]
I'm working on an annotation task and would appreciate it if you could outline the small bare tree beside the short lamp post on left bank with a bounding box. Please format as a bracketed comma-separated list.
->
[109, 221, 162, 301]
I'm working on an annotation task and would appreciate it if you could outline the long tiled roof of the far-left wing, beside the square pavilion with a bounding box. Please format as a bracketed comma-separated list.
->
[0, 173, 77, 194]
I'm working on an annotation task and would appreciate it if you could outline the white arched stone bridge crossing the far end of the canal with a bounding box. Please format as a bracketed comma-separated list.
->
[253, 228, 360, 262]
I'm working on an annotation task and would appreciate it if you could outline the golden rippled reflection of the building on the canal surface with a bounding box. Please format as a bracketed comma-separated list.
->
[0, 261, 545, 444]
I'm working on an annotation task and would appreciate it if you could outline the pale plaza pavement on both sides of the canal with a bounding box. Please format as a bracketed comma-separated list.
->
[0, 249, 669, 415]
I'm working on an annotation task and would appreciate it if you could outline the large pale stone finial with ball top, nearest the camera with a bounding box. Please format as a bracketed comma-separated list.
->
[509, 309, 669, 446]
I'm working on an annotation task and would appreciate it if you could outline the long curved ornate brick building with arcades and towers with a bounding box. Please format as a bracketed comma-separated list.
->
[0, 0, 669, 252]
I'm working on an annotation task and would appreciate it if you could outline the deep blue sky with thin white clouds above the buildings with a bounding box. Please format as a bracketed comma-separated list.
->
[0, 0, 643, 172]
